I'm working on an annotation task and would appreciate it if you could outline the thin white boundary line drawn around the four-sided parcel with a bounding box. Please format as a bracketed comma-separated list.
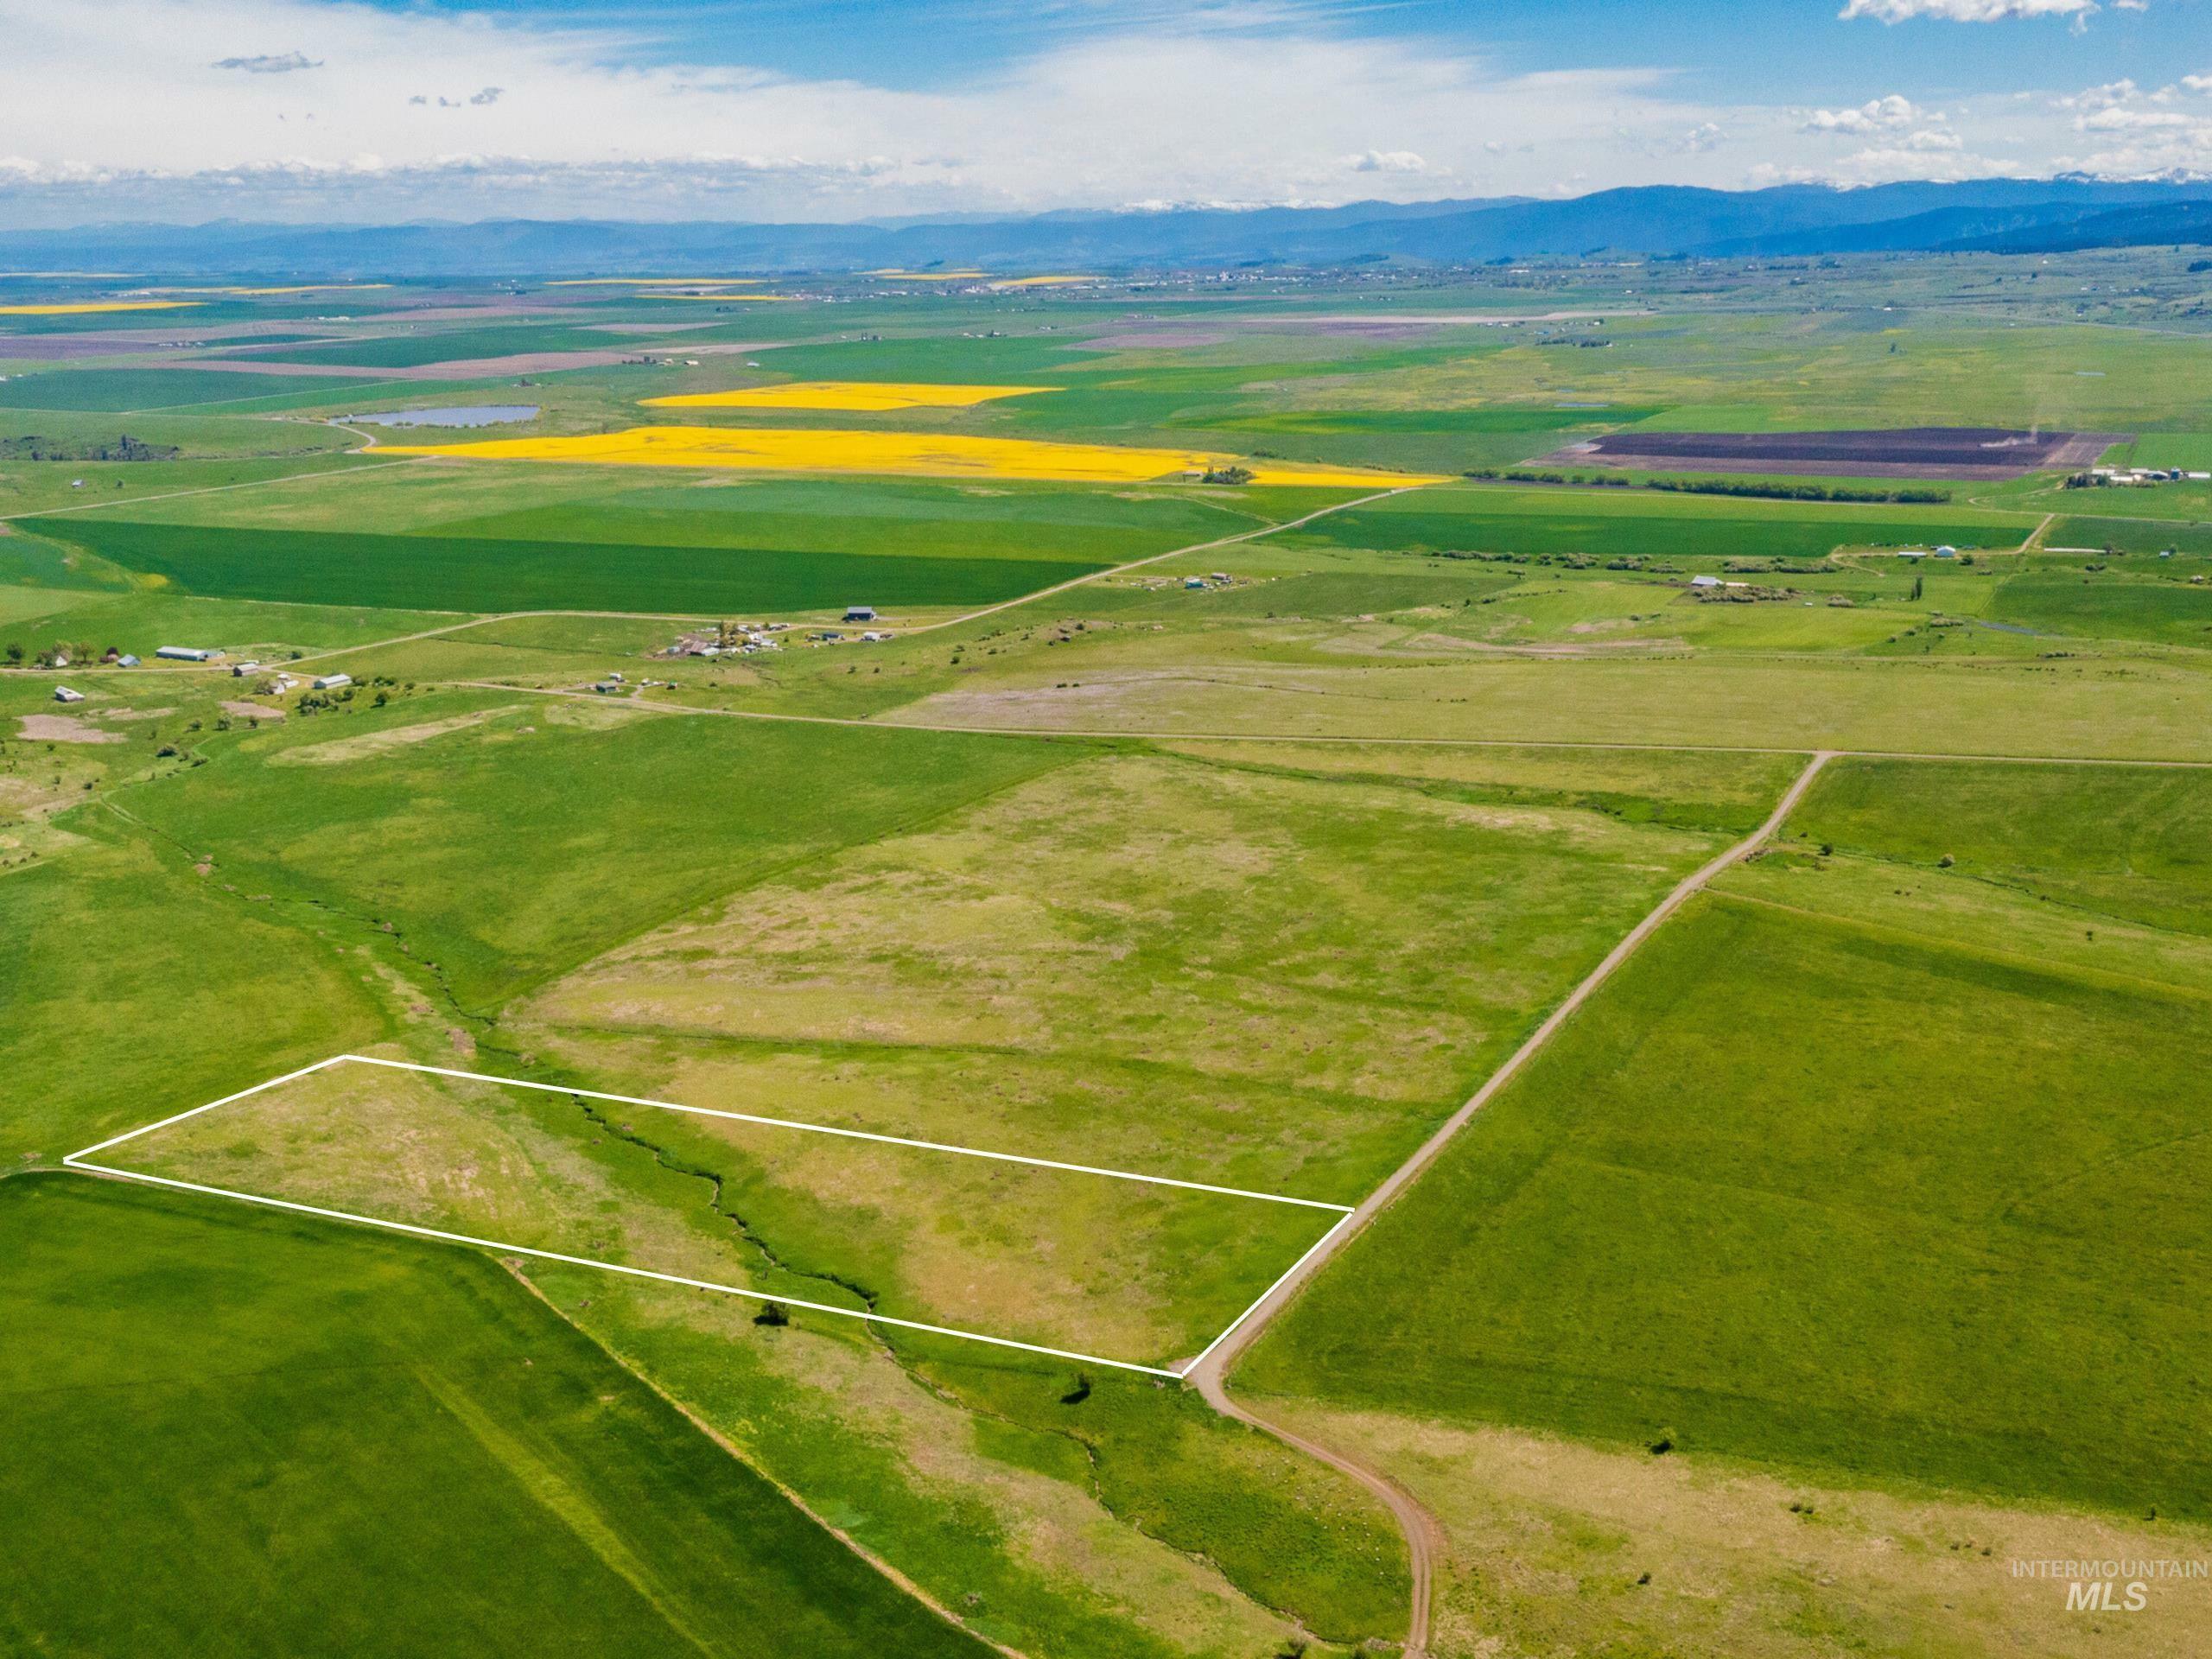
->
[62, 1055, 1351, 1380]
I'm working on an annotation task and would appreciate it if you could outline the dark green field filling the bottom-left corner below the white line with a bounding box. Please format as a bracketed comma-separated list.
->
[0, 1174, 987, 1656]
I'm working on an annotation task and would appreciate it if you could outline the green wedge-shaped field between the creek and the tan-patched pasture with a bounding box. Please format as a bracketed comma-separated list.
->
[111, 692, 1082, 1008]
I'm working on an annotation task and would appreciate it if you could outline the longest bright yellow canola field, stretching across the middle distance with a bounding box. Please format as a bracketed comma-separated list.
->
[376, 427, 1451, 489]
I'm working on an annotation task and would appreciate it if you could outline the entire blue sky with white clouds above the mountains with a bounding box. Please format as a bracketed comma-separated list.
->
[0, 0, 2212, 224]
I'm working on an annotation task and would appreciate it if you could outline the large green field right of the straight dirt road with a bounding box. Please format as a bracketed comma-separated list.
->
[1243, 763, 2212, 1520]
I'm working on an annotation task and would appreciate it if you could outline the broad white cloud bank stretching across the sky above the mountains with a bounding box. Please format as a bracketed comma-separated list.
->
[0, 0, 2212, 224]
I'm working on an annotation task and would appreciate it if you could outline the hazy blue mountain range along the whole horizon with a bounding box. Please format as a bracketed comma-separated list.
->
[0, 179, 2212, 276]
